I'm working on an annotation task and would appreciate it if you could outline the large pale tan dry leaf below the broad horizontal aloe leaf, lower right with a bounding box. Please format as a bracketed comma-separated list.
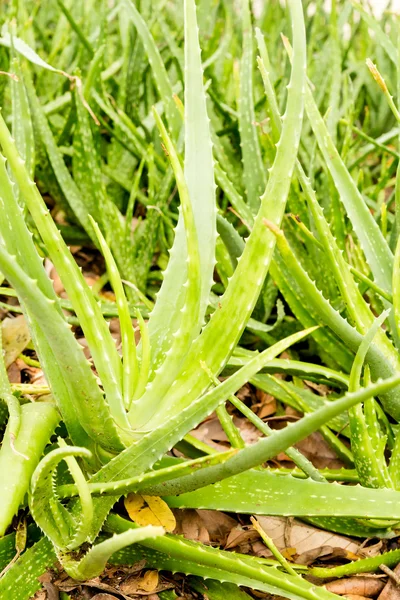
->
[257, 516, 359, 556]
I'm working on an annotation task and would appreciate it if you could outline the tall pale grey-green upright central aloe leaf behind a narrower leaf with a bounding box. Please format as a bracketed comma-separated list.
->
[145, 0, 216, 369]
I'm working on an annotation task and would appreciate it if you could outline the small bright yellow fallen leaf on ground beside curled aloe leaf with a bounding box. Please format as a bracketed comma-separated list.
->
[125, 494, 176, 531]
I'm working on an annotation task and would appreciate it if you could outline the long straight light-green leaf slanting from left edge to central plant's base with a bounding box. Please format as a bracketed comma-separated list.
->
[0, 111, 129, 436]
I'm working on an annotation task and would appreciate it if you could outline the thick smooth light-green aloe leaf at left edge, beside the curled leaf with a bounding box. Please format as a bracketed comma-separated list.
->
[0, 402, 59, 536]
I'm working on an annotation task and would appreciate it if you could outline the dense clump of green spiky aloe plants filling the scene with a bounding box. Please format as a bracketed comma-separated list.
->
[0, 0, 400, 600]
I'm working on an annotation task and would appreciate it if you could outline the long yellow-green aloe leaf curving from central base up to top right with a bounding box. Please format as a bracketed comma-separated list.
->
[145, 0, 305, 427]
